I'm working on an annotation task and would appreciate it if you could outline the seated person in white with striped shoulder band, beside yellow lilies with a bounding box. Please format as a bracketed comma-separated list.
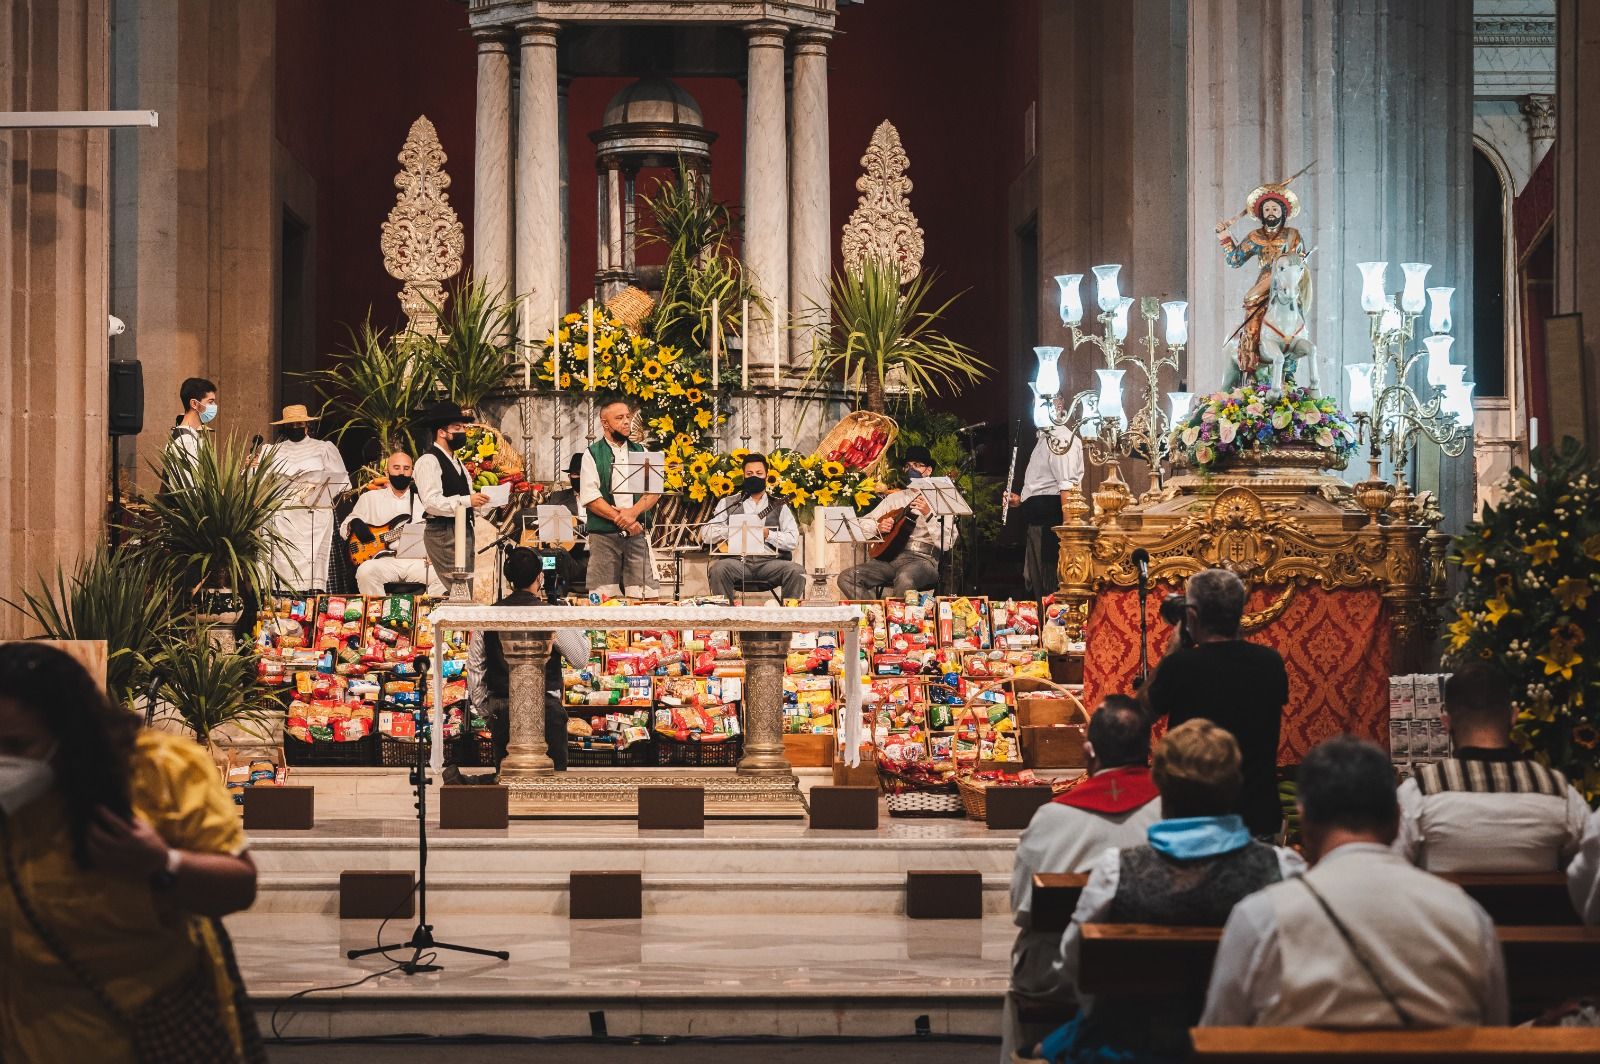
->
[1395, 662, 1589, 872]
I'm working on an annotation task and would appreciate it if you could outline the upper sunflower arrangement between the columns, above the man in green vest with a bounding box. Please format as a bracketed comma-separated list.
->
[534, 306, 728, 446]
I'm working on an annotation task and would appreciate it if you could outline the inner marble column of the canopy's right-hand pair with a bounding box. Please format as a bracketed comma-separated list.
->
[744, 22, 789, 384]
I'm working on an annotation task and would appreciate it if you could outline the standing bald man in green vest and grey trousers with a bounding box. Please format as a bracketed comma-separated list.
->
[578, 398, 661, 598]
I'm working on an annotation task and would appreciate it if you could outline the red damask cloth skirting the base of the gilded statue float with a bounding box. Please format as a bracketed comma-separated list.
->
[1083, 586, 1389, 765]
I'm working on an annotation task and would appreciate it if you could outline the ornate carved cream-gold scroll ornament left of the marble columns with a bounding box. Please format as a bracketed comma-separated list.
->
[379, 115, 467, 336]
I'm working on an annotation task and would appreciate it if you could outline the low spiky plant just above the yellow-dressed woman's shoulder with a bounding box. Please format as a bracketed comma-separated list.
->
[146, 626, 280, 744]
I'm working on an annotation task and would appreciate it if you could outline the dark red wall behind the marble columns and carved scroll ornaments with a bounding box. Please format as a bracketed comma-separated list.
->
[277, 0, 1037, 418]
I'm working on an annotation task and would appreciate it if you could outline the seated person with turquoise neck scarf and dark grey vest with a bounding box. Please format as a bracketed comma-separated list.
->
[1038, 720, 1299, 1061]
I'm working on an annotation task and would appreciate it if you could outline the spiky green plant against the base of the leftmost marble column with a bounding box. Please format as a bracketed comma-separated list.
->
[421, 275, 522, 408]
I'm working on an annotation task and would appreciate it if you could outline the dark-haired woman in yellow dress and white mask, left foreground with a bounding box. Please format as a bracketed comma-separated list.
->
[0, 643, 264, 1064]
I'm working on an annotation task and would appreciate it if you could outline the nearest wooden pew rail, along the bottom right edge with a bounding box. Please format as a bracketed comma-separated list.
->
[1189, 1027, 1600, 1064]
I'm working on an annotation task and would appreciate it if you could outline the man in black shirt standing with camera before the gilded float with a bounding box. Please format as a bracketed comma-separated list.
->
[1149, 570, 1290, 838]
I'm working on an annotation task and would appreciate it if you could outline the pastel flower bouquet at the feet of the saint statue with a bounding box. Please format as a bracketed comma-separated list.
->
[1171, 384, 1357, 470]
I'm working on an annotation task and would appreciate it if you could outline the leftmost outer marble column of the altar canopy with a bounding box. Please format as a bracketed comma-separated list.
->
[472, 30, 514, 293]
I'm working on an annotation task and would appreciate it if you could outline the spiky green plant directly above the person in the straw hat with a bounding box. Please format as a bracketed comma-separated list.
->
[301, 312, 437, 454]
